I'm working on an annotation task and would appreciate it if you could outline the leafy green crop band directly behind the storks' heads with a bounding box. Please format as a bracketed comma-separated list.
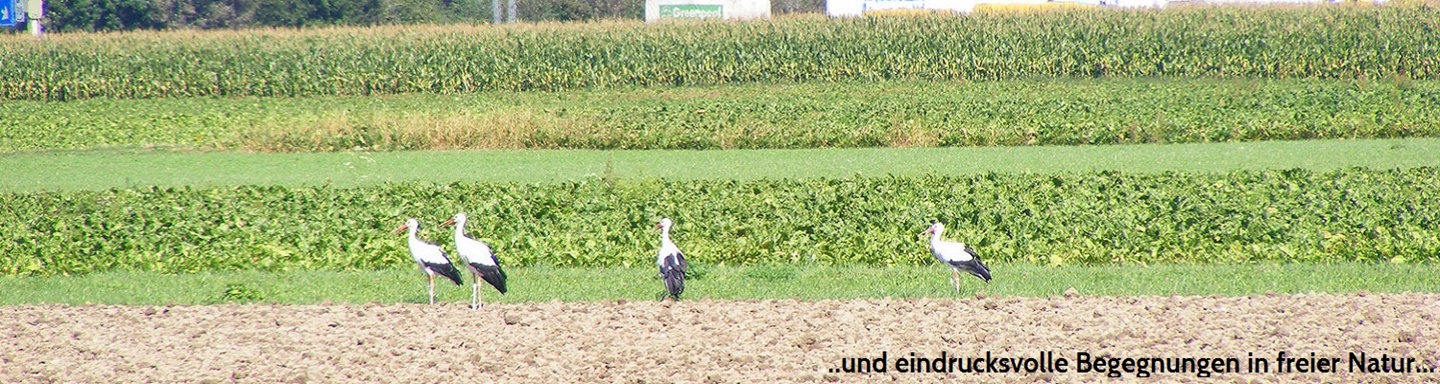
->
[0, 168, 1440, 275]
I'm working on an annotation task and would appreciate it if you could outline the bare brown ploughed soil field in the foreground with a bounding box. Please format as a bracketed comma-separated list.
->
[0, 293, 1440, 383]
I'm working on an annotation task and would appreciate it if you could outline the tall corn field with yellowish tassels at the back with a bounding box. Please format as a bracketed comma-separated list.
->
[0, 7, 1440, 101]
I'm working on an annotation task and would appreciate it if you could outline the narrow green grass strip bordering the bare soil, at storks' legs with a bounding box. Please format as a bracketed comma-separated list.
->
[0, 263, 1440, 305]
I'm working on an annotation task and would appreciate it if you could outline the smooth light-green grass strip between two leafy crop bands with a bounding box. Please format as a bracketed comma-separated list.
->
[0, 138, 1440, 191]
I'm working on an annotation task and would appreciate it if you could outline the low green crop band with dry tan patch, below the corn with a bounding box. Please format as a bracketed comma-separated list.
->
[0, 79, 1440, 151]
